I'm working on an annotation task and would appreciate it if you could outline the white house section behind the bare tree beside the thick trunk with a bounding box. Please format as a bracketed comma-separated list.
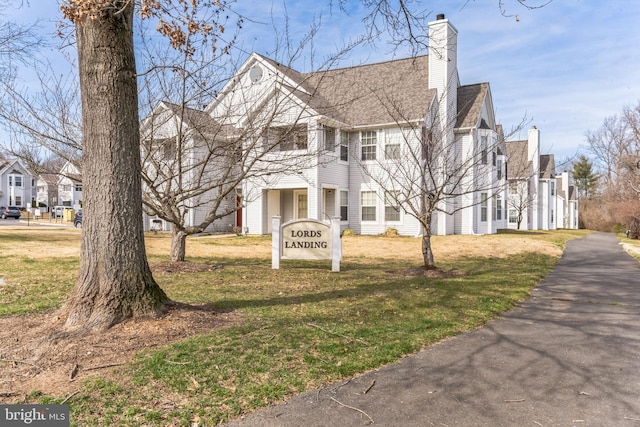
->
[141, 102, 242, 232]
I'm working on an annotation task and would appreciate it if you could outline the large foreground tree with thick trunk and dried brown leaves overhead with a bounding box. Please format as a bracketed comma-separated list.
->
[1, 0, 544, 330]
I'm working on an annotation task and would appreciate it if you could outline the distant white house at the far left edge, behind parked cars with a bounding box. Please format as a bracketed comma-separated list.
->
[0, 155, 35, 208]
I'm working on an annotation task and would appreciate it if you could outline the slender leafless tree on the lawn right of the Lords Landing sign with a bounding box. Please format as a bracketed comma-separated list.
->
[352, 81, 516, 269]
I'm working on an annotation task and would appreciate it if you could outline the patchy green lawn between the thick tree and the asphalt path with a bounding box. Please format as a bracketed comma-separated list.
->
[0, 227, 586, 426]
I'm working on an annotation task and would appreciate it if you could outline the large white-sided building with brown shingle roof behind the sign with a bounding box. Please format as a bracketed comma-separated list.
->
[205, 15, 507, 235]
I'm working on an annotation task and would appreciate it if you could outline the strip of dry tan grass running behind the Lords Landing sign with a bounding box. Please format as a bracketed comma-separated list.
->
[0, 225, 562, 262]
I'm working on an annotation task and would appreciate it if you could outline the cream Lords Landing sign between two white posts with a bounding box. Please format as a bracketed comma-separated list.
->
[271, 216, 342, 271]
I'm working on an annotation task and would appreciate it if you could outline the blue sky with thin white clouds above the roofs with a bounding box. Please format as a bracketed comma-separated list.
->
[5, 0, 640, 164]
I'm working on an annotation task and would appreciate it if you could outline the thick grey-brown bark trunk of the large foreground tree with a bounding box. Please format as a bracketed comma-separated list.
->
[65, 2, 168, 330]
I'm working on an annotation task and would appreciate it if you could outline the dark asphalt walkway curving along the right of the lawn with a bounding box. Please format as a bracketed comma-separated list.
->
[229, 233, 640, 427]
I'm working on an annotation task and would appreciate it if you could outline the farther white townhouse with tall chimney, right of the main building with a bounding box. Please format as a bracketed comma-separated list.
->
[506, 126, 564, 230]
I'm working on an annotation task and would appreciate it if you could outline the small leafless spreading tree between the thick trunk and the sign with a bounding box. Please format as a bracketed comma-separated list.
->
[137, 11, 362, 261]
